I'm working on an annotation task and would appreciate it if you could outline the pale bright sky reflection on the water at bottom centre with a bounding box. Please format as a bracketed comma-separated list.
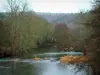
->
[42, 63, 87, 75]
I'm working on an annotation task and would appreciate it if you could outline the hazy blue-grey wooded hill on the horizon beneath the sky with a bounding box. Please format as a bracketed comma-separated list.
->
[36, 12, 78, 29]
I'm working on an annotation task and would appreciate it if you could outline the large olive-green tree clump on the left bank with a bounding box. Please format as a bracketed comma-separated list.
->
[0, 0, 53, 56]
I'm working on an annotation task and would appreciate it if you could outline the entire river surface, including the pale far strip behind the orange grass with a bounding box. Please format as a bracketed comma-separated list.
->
[0, 52, 91, 75]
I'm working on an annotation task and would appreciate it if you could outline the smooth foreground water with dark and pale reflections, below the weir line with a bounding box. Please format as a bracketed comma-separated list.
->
[0, 61, 87, 75]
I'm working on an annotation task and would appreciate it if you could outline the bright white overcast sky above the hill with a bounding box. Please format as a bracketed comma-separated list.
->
[0, 0, 91, 13]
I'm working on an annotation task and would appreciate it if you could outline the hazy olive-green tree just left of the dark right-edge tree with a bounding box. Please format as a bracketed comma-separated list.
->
[72, 12, 92, 50]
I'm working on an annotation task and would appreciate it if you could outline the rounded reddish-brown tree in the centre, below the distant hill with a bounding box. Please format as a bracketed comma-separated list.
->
[54, 24, 75, 49]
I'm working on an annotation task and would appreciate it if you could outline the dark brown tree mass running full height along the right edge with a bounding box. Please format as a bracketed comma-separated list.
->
[82, 0, 100, 75]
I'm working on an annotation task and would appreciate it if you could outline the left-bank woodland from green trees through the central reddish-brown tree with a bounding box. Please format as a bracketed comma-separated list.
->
[0, 0, 80, 57]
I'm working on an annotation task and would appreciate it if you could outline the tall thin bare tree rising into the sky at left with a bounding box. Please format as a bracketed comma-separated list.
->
[6, 0, 27, 55]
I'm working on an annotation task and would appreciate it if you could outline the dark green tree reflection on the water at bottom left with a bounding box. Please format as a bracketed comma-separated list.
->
[0, 62, 39, 75]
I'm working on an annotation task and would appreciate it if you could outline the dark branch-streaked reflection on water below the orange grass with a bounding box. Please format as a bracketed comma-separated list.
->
[58, 63, 92, 75]
